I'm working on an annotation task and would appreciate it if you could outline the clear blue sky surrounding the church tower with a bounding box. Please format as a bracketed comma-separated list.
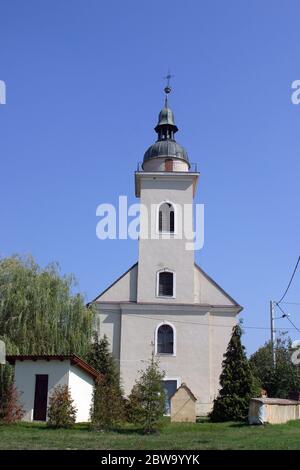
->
[0, 0, 300, 353]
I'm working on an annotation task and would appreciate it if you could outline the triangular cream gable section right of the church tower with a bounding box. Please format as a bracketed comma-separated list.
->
[194, 263, 239, 307]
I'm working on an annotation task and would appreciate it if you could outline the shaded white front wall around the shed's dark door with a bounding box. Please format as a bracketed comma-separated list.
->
[15, 361, 70, 421]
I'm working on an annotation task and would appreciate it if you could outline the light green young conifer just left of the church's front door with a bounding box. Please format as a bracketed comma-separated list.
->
[128, 354, 165, 434]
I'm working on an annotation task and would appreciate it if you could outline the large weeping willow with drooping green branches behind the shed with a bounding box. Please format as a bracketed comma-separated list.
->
[0, 256, 92, 356]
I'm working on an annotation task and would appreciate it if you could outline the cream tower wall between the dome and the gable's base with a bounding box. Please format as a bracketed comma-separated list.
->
[137, 174, 194, 303]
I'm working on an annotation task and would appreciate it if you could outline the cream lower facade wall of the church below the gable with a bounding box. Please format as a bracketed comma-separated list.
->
[120, 306, 236, 414]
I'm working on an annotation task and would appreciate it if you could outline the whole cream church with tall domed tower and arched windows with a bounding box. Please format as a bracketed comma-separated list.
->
[92, 86, 242, 415]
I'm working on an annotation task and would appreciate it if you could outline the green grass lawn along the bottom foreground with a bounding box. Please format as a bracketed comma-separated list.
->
[0, 420, 300, 450]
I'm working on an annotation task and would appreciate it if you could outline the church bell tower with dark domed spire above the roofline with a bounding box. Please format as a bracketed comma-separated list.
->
[135, 84, 199, 304]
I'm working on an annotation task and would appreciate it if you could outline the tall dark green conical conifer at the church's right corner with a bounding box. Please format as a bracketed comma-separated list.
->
[210, 325, 254, 422]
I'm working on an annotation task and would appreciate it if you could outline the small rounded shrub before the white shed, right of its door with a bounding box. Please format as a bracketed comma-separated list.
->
[47, 385, 77, 428]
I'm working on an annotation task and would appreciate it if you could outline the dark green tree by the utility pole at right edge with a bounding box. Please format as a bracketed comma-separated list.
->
[249, 333, 300, 398]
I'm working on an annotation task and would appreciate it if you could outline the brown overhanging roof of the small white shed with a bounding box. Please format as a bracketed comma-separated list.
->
[6, 354, 101, 380]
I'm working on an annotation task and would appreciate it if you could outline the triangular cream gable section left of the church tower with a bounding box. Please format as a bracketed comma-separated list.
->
[94, 263, 138, 302]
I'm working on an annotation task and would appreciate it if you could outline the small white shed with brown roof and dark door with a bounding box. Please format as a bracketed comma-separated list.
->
[6, 355, 99, 423]
